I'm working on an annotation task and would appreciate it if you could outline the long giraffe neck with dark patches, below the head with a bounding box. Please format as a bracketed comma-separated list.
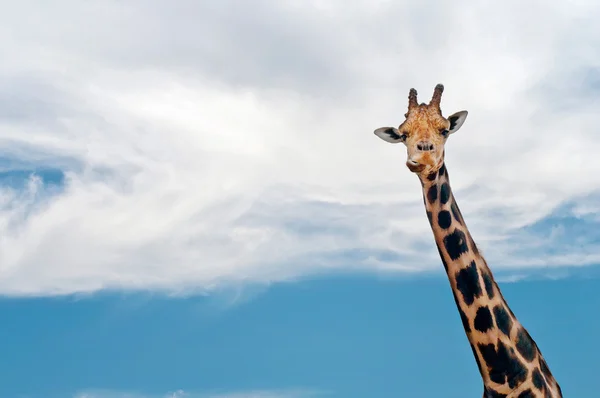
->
[420, 164, 562, 398]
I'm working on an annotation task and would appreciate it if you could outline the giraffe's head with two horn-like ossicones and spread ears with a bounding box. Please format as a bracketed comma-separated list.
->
[374, 84, 467, 175]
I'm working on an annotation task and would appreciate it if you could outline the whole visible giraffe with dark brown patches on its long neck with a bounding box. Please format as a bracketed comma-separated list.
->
[374, 84, 562, 398]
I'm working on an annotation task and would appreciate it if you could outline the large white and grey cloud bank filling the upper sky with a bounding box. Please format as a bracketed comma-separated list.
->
[0, 0, 600, 295]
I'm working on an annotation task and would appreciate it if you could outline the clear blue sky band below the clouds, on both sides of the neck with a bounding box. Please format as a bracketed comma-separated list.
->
[0, 275, 600, 398]
